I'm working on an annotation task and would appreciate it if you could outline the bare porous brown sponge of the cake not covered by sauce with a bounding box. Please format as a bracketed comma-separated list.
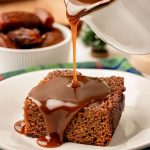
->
[24, 70, 125, 146]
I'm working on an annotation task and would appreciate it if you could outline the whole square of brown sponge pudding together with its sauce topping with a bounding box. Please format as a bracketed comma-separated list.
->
[15, 70, 125, 147]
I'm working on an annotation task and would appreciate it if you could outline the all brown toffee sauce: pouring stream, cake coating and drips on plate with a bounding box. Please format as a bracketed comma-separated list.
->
[15, 0, 110, 147]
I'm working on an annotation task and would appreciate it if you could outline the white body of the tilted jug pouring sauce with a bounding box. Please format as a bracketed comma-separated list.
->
[81, 0, 150, 54]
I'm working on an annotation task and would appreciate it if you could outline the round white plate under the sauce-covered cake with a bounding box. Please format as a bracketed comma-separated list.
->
[0, 69, 150, 150]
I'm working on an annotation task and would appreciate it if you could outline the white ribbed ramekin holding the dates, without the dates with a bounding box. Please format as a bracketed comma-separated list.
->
[0, 23, 71, 73]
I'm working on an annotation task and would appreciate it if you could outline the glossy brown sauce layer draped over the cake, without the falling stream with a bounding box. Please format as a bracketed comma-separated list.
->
[28, 75, 110, 147]
